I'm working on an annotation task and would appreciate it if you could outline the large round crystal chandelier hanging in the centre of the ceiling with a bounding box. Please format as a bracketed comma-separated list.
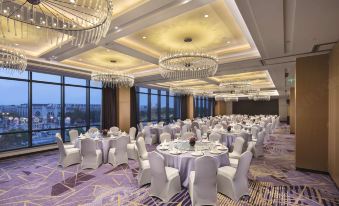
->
[159, 37, 218, 80]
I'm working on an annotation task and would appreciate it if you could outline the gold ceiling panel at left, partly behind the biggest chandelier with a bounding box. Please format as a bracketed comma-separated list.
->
[0, 17, 70, 57]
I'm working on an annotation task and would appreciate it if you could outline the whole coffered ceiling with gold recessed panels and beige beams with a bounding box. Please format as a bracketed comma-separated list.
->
[0, 0, 339, 96]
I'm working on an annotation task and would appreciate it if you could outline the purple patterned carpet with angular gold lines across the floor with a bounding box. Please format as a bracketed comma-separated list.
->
[0, 124, 339, 206]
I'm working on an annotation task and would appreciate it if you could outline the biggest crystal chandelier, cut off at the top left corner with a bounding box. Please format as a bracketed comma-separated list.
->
[0, 0, 113, 47]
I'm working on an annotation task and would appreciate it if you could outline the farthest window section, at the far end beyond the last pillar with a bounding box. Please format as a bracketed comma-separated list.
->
[194, 96, 214, 117]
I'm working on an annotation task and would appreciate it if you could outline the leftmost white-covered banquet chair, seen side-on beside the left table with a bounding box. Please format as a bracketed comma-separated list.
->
[55, 133, 81, 168]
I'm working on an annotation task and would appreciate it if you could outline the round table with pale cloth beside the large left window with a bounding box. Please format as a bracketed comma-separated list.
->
[74, 134, 129, 163]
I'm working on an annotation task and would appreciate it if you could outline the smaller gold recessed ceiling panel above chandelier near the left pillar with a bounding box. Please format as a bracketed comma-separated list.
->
[62, 47, 155, 74]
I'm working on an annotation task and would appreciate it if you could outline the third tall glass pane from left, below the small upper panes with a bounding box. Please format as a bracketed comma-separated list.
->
[65, 86, 86, 127]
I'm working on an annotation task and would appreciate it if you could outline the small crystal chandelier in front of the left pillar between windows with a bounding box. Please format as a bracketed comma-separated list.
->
[91, 72, 134, 88]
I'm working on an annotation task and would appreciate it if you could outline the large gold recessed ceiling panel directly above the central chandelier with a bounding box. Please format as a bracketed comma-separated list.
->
[117, 0, 251, 57]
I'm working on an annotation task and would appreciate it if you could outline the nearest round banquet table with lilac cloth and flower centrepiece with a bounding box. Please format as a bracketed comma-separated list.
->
[156, 141, 230, 187]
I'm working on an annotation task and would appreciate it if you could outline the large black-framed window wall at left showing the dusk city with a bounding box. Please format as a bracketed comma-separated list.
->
[0, 71, 102, 152]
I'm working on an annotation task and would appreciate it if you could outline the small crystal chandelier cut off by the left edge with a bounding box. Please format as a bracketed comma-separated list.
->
[0, 45, 27, 73]
